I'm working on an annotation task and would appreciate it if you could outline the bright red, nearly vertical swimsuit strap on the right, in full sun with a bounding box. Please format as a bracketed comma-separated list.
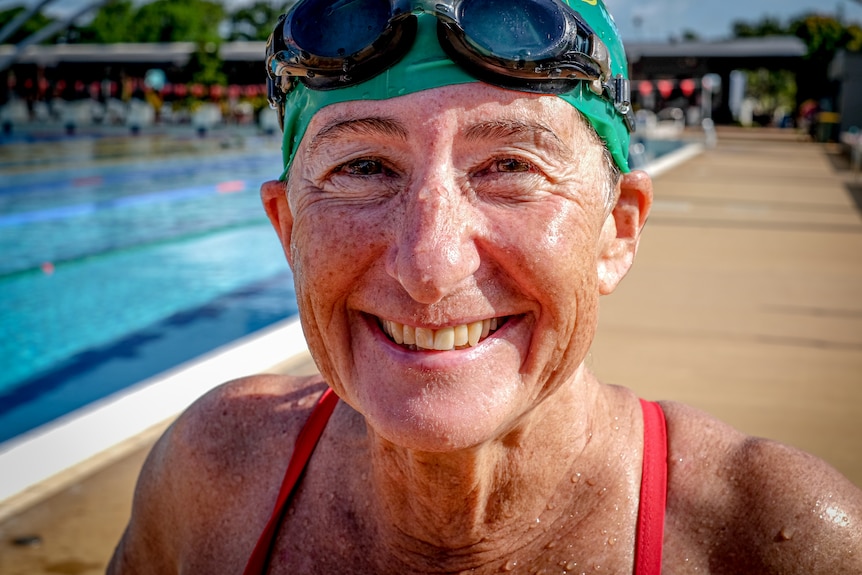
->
[635, 400, 667, 575]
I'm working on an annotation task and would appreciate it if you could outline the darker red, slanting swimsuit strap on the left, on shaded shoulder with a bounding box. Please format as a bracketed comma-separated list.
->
[243, 388, 338, 575]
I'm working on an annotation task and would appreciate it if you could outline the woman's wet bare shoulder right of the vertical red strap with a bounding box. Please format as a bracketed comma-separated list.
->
[662, 403, 862, 574]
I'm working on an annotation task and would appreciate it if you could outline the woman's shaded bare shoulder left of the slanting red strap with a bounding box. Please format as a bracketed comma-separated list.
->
[108, 375, 325, 573]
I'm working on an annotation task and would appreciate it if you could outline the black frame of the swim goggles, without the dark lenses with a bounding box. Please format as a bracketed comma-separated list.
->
[266, 0, 634, 132]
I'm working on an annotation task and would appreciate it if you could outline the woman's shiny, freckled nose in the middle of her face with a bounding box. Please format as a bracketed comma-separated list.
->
[386, 177, 479, 305]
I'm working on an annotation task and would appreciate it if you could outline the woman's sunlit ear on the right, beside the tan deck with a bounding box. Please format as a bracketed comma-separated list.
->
[598, 171, 652, 295]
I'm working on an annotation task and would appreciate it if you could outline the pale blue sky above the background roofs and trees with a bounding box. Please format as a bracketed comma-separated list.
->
[5, 0, 862, 42]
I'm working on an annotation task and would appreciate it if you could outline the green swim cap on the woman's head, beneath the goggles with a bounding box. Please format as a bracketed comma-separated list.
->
[281, 0, 630, 180]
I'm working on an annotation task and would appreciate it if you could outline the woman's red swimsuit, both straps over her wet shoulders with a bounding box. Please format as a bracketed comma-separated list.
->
[243, 389, 667, 575]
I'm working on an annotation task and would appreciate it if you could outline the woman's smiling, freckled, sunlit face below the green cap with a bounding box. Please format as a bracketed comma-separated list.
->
[263, 84, 648, 451]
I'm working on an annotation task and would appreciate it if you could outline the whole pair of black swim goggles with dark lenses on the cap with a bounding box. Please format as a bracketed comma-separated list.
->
[266, 0, 634, 132]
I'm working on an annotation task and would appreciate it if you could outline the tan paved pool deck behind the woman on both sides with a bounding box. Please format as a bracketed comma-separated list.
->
[0, 129, 862, 575]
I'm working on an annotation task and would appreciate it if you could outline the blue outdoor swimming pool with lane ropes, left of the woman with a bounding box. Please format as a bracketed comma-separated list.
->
[0, 133, 296, 442]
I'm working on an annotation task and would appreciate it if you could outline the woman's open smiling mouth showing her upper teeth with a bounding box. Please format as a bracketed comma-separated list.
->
[377, 317, 509, 351]
